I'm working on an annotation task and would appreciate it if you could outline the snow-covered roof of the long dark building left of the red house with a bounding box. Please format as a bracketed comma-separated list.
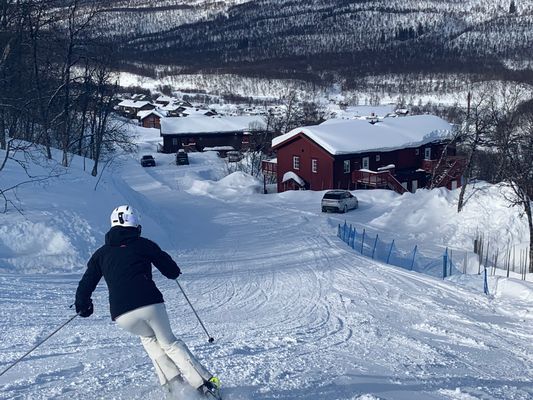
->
[161, 116, 266, 135]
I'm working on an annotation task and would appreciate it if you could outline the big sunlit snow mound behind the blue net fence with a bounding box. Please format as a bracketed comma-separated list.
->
[370, 184, 529, 251]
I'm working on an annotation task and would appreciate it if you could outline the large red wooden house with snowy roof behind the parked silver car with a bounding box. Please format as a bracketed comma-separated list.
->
[272, 115, 464, 193]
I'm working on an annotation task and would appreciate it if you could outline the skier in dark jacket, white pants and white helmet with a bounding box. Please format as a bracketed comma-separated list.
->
[75, 205, 220, 399]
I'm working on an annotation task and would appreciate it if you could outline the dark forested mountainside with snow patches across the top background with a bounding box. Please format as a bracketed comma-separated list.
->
[79, 0, 533, 79]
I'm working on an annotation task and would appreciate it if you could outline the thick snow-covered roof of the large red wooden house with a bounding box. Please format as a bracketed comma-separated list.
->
[272, 115, 452, 155]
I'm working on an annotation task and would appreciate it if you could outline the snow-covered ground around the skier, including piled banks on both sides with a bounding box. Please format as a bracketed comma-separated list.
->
[0, 129, 533, 400]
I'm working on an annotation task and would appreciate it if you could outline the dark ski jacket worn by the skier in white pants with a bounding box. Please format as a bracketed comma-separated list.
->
[76, 226, 180, 320]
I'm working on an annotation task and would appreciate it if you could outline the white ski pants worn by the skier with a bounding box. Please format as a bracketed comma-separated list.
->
[116, 303, 212, 388]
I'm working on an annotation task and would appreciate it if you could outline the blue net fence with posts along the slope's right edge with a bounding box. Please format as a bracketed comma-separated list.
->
[337, 222, 488, 294]
